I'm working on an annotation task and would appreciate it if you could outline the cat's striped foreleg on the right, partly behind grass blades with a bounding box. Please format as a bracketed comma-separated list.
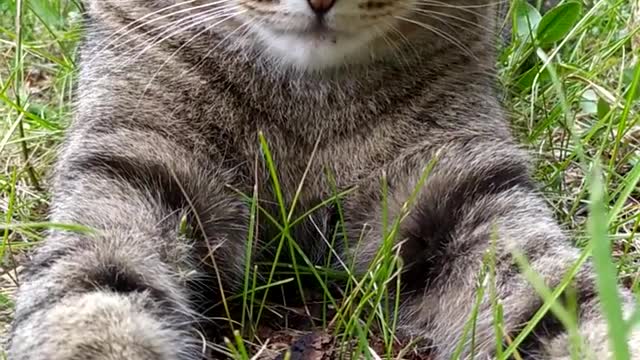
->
[345, 138, 640, 359]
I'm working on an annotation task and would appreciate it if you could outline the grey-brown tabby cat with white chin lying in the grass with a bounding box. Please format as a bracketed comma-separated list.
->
[9, 0, 640, 360]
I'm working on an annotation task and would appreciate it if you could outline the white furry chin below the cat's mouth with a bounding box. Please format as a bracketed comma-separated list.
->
[259, 29, 371, 72]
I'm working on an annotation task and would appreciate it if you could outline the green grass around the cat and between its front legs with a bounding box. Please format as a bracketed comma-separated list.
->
[0, 0, 640, 359]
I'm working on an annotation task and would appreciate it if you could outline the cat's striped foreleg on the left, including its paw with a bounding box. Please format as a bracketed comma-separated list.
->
[9, 131, 246, 360]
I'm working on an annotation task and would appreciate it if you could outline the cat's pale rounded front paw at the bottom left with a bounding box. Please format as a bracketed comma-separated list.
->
[9, 291, 197, 360]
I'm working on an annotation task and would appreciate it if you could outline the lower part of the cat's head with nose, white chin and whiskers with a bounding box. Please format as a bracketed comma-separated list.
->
[89, 0, 495, 71]
